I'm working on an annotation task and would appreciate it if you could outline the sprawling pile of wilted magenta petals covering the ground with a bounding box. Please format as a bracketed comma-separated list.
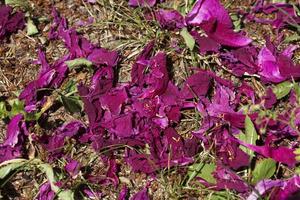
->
[0, 0, 300, 200]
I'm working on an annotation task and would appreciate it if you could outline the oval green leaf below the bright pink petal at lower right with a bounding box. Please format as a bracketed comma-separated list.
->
[252, 158, 276, 184]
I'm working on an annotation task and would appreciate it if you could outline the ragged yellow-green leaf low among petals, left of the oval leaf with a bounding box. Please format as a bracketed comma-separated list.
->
[188, 163, 216, 184]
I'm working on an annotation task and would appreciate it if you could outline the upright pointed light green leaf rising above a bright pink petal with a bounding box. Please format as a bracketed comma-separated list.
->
[243, 115, 258, 158]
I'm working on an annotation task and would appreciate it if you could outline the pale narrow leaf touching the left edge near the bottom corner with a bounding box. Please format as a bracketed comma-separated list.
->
[0, 159, 27, 180]
